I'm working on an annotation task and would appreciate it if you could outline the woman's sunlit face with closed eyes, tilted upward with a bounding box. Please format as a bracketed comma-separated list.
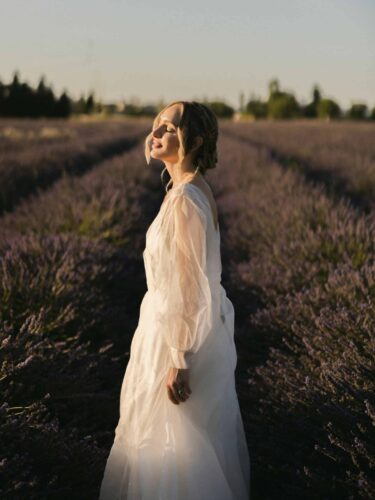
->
[151, 104, 182, 163]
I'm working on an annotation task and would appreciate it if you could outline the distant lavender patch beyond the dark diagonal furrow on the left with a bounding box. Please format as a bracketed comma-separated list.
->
[0, 121, 151, 214]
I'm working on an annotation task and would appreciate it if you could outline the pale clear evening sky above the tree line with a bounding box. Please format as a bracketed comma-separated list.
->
[0, 0, 375, 108]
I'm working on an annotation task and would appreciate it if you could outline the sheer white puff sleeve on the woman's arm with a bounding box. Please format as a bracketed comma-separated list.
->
[156, 192, 212, 369]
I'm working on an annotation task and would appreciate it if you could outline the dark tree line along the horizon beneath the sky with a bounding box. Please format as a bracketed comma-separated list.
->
[0, 71, 375, 120]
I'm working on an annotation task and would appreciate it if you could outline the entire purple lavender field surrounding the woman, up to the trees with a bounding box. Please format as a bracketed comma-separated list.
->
[0, 121, 375, 500]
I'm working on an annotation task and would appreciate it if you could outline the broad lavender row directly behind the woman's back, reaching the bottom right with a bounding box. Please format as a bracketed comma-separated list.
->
[213, 135, 375, 499]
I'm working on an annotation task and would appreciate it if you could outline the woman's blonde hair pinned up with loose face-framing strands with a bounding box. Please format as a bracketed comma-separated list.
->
[145, 101, 219, 187]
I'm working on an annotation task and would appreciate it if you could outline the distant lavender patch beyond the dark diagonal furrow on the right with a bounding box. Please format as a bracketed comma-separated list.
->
[223, 122, 375, 212]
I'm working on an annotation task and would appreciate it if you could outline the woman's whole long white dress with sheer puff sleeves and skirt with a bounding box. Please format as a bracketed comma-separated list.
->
[99, 183, 250, 500]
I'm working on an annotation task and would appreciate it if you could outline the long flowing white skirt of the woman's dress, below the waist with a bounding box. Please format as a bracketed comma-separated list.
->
[99, 285, 250, 500]
